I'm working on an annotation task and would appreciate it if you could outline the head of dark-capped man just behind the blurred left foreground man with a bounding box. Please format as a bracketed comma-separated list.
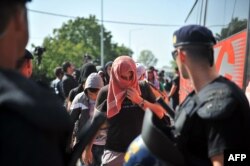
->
[16, 49, 34, 78]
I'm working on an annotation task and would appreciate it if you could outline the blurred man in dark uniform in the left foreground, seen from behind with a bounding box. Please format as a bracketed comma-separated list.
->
[0, 0, 73, 166]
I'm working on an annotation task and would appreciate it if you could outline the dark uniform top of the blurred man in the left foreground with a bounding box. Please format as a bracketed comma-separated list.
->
[0, 69, 73, 166]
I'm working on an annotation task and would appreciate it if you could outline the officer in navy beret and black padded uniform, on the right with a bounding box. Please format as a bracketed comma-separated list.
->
[172, 25, 250, 166]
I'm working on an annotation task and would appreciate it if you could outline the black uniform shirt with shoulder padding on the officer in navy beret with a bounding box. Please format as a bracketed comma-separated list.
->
[175, 77, 250, 165]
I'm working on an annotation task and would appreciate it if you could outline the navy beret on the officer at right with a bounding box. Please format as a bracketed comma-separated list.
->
[173, 25, 216, 47]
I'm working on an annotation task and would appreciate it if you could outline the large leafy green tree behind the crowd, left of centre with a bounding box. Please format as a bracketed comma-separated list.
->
[31, 16, 131, 78]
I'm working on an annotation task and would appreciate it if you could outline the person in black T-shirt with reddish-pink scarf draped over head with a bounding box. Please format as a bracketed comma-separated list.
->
[83, 56, 165, 166]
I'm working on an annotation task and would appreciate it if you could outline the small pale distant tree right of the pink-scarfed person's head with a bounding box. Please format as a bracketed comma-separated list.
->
[137, 50, 158, 67]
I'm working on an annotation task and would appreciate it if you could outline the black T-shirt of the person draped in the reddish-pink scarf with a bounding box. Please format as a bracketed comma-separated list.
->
[96, 84, 155, 153]
